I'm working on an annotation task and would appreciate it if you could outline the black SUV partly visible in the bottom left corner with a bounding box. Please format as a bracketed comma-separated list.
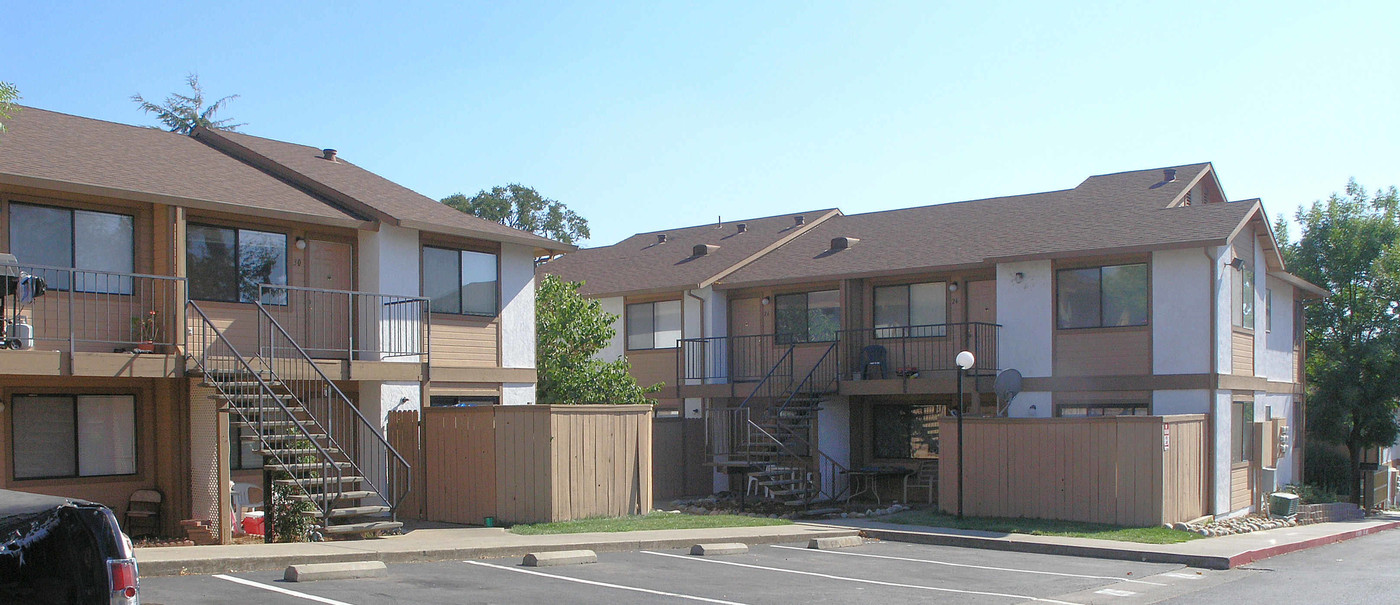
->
[0, 490, 141, 605]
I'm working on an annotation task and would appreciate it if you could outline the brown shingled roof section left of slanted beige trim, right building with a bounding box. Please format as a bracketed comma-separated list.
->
[540, 209, 840, 297]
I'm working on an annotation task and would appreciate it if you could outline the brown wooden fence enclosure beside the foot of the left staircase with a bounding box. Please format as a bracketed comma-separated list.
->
[389, 405, 652, 525]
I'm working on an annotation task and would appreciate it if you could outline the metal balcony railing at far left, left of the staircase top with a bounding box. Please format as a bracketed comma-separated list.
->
[0, 265, 186, 353]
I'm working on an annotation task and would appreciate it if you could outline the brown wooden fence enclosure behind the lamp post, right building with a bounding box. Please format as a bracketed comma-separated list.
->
[938, 415, 1210, 527]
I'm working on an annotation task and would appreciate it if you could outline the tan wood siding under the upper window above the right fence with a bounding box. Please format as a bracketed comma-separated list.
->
[1054, 328, 1152, 375]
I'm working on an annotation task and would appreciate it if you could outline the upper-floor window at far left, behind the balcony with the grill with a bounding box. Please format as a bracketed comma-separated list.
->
[10, 203, 136, 294]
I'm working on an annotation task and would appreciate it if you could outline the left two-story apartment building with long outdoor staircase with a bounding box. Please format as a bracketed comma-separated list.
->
[0, 108, 571, 535]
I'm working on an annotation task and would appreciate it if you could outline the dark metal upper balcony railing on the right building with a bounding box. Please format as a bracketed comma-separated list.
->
[678, 322, 1001, 398]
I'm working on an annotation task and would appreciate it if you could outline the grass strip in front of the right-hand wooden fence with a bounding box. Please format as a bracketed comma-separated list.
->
[872, 511, 1201, 543]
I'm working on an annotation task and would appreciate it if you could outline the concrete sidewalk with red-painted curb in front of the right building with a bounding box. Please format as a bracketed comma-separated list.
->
[822, 515, 1400, 570]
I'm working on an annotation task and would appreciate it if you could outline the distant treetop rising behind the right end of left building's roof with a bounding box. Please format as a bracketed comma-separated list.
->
[442, 183, 588, 244]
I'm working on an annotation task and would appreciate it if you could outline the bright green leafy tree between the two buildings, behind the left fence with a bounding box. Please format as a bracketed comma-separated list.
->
[535, 276, 662, 403]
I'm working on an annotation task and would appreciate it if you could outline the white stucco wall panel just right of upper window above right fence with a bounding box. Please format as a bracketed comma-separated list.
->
[1152, 248, 1211, 372]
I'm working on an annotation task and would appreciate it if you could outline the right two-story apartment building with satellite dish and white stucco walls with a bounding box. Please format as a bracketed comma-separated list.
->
[545, 164, 1326, 514]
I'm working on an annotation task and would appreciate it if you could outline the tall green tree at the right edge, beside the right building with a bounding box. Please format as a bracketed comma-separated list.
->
[1274, 181, 1400, 504]
